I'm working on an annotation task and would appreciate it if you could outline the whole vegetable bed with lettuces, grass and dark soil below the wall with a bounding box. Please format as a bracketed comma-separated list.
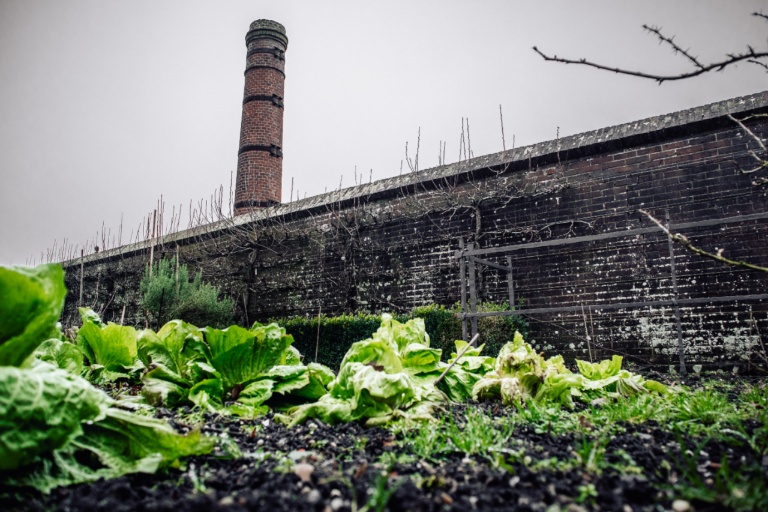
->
[0, 265, 768, 512]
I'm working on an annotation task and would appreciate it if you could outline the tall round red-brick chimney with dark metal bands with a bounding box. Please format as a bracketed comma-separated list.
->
[234, 20, 288, 215]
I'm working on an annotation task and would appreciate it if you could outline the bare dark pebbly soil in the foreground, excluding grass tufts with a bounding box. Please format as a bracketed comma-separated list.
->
[0, 374, 768, 512]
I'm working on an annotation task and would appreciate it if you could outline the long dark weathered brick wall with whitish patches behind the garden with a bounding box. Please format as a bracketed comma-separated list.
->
[61, 93, 768, 369]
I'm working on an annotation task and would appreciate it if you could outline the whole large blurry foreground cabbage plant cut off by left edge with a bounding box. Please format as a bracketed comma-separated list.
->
[0, 265, 213, 492]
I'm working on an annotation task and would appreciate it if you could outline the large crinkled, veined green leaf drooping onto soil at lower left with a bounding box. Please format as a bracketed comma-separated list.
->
[0, 363, 213, 492]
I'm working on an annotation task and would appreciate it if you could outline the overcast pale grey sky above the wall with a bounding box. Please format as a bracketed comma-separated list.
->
[0, 0, 768, 264]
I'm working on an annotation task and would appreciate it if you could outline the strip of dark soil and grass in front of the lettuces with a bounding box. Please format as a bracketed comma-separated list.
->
[7, 376, 768, 512]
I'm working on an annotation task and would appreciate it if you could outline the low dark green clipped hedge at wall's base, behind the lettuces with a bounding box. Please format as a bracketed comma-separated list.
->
[270, 303, 528, 370]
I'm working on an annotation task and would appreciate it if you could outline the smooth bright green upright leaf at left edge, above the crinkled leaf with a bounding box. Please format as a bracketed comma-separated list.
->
[0, 264, 67, 366]
